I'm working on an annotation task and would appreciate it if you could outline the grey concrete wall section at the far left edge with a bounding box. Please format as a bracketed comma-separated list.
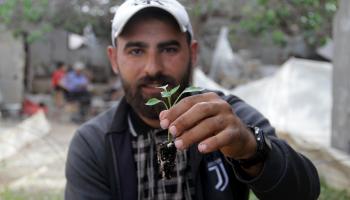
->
[0, 27, 24, 107]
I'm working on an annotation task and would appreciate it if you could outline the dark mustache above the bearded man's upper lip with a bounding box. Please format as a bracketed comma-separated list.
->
[136, 73, 176, 88]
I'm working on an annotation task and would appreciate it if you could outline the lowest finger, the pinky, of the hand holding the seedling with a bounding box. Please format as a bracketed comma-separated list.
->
[198, 128, 242, 154]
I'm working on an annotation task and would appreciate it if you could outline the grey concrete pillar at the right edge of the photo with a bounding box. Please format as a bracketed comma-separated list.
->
[332, 0, 350, 153]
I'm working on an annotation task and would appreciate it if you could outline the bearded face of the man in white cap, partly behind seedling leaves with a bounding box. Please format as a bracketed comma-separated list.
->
[109, 19, 197, 119]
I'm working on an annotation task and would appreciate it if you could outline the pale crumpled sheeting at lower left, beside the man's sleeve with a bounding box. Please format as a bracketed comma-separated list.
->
[0, 117, 78, 196]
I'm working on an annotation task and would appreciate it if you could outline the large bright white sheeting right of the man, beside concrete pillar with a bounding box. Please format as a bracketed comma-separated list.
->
[232, 58, 332, 146]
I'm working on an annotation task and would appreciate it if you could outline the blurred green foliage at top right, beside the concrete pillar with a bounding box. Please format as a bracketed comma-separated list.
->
[240, 0, 338, 48]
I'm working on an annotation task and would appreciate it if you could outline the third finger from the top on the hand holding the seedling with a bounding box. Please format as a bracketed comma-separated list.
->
[175, 116, 225, 150]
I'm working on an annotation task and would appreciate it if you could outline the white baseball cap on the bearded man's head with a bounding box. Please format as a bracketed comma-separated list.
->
[112, 0, 193, 46]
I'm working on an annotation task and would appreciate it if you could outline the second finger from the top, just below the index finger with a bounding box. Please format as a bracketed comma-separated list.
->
[169, 102, 223, 137]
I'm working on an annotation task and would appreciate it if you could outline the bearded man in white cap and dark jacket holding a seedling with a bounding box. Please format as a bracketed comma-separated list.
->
[65, 0, 320, 200]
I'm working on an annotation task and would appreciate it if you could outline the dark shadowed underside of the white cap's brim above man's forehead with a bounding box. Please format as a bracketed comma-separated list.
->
[115, 7, 192, 45]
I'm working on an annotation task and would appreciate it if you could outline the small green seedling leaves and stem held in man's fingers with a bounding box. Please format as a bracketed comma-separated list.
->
[146, 85, 203, 143]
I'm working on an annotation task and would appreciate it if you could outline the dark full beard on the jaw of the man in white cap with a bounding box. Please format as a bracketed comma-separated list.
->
[120, 61, 193, 119]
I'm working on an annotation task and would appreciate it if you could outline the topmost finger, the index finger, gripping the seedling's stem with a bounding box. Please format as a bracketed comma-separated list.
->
[159, 92, 219, 129]
